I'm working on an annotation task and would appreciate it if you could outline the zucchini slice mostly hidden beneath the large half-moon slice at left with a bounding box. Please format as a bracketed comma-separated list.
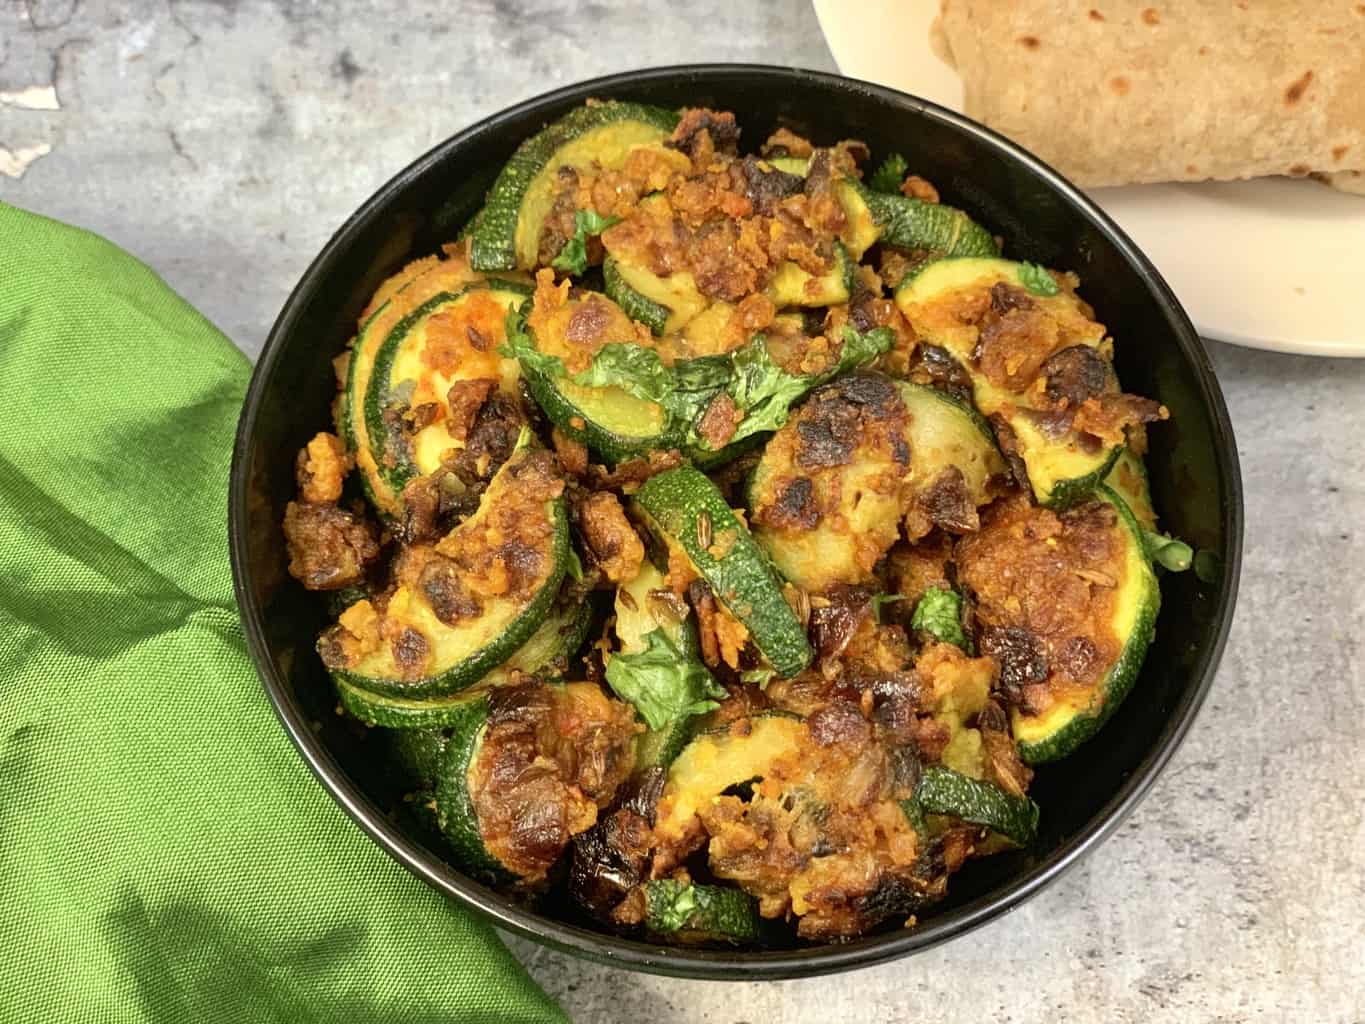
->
[334, 602, 592, 730]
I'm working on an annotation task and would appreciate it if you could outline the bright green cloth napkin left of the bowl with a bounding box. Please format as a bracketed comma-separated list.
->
[0, 203, 564, 1024]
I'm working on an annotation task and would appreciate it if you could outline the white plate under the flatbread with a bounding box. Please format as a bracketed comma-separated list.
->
[815, 0, 1365, 356]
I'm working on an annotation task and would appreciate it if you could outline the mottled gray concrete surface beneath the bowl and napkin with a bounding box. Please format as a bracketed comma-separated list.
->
[0, 0, 1365, 1024]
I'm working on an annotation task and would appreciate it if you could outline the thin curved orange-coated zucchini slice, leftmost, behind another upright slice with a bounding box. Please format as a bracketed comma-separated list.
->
[337, 258, 479, 517]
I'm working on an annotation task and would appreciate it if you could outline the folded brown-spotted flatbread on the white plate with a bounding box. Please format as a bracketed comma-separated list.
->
[935, 0, 1365, 194]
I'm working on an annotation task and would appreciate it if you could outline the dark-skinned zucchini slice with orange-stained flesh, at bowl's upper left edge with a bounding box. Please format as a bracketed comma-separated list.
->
[364, 279, 531, 494]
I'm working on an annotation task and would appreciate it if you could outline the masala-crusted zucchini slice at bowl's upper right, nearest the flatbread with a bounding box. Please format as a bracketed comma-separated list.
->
[895, 258, 1160, 507]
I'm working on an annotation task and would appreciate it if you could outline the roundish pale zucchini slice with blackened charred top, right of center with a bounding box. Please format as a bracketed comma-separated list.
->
[749, 373, 1005, 593]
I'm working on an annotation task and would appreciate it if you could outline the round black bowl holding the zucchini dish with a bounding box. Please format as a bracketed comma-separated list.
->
[231, 64, 1242, 979]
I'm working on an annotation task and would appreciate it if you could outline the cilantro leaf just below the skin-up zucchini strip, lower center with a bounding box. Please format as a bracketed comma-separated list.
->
[606, 629, 726, 730]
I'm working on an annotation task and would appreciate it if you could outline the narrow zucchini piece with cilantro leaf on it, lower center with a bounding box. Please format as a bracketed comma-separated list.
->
[606, 561, 726, 767]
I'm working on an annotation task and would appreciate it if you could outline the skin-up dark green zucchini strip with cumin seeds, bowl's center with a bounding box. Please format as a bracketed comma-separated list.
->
[632, 466, 814, 677]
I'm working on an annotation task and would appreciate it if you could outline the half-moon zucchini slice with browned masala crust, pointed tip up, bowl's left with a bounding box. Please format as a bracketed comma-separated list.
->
[318, 442, 569, 700]
